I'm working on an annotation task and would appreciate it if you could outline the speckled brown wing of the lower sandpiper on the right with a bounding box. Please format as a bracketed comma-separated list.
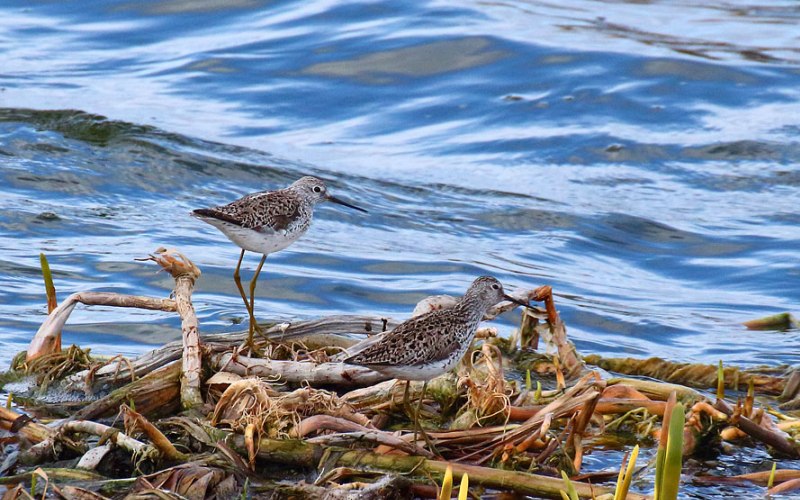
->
[344, 311, 468, 367]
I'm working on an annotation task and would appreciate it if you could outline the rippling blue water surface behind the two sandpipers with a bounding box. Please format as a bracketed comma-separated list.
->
[0, 0, 800, 494]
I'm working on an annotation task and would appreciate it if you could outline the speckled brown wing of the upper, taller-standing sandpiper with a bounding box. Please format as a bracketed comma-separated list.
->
[194, 190, 301, 231]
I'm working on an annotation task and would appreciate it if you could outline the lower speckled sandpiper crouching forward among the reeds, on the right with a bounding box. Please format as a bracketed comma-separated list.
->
[344, 276, 530, 446]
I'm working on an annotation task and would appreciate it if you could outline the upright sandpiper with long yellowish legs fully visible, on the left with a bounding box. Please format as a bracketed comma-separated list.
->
[192, 176, 366, 346]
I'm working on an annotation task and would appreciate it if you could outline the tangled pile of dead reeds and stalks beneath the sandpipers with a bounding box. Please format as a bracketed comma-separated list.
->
[0, 249, 800, 499]
